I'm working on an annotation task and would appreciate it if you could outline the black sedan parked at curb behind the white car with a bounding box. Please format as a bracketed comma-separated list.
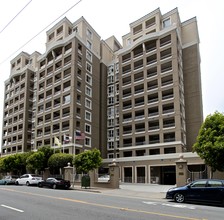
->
[38, 177, 71, 189]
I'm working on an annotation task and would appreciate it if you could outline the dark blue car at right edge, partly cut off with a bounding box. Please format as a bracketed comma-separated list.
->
[166, 179, 224, 205]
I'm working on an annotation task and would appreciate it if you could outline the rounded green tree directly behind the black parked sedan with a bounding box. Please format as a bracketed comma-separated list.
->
[48, 153, 73, 174]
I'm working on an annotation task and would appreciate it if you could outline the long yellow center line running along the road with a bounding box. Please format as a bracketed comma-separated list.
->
[0, 188, 203, 220]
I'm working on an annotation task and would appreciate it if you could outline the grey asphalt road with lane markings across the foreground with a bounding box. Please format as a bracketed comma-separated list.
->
[0, 186, 224, 220]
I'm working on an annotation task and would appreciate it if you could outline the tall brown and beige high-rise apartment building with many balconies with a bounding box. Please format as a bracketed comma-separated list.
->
[2, 9, 203, 184]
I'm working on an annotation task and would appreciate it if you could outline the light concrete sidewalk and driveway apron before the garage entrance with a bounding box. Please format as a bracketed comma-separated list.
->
[74, 183, 174, 199]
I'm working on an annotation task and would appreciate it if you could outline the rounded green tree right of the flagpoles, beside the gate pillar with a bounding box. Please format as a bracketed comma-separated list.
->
[73, 149, 102, 173]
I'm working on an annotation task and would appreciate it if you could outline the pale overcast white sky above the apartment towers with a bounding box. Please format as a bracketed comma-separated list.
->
[0, 0, 224, 144]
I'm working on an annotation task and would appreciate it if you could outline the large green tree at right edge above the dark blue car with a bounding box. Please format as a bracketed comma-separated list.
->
[193, 112, 224, 173]
